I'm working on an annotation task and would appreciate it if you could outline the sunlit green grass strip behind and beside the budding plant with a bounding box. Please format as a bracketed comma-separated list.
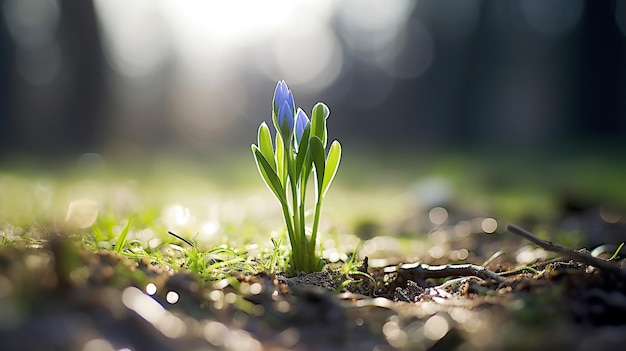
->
[0, 147, 626, 281]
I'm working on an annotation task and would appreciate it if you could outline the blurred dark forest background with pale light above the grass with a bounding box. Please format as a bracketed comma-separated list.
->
[0, 0, 626, 158]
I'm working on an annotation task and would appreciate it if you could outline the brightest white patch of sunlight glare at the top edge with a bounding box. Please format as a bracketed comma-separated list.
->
[166, 0, 297, 80]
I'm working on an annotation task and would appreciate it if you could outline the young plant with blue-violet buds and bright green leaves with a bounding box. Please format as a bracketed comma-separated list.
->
[252, 80, 341, 273]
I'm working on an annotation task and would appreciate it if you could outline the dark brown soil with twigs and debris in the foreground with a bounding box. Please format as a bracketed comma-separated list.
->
[0, 213, 626, 351]
